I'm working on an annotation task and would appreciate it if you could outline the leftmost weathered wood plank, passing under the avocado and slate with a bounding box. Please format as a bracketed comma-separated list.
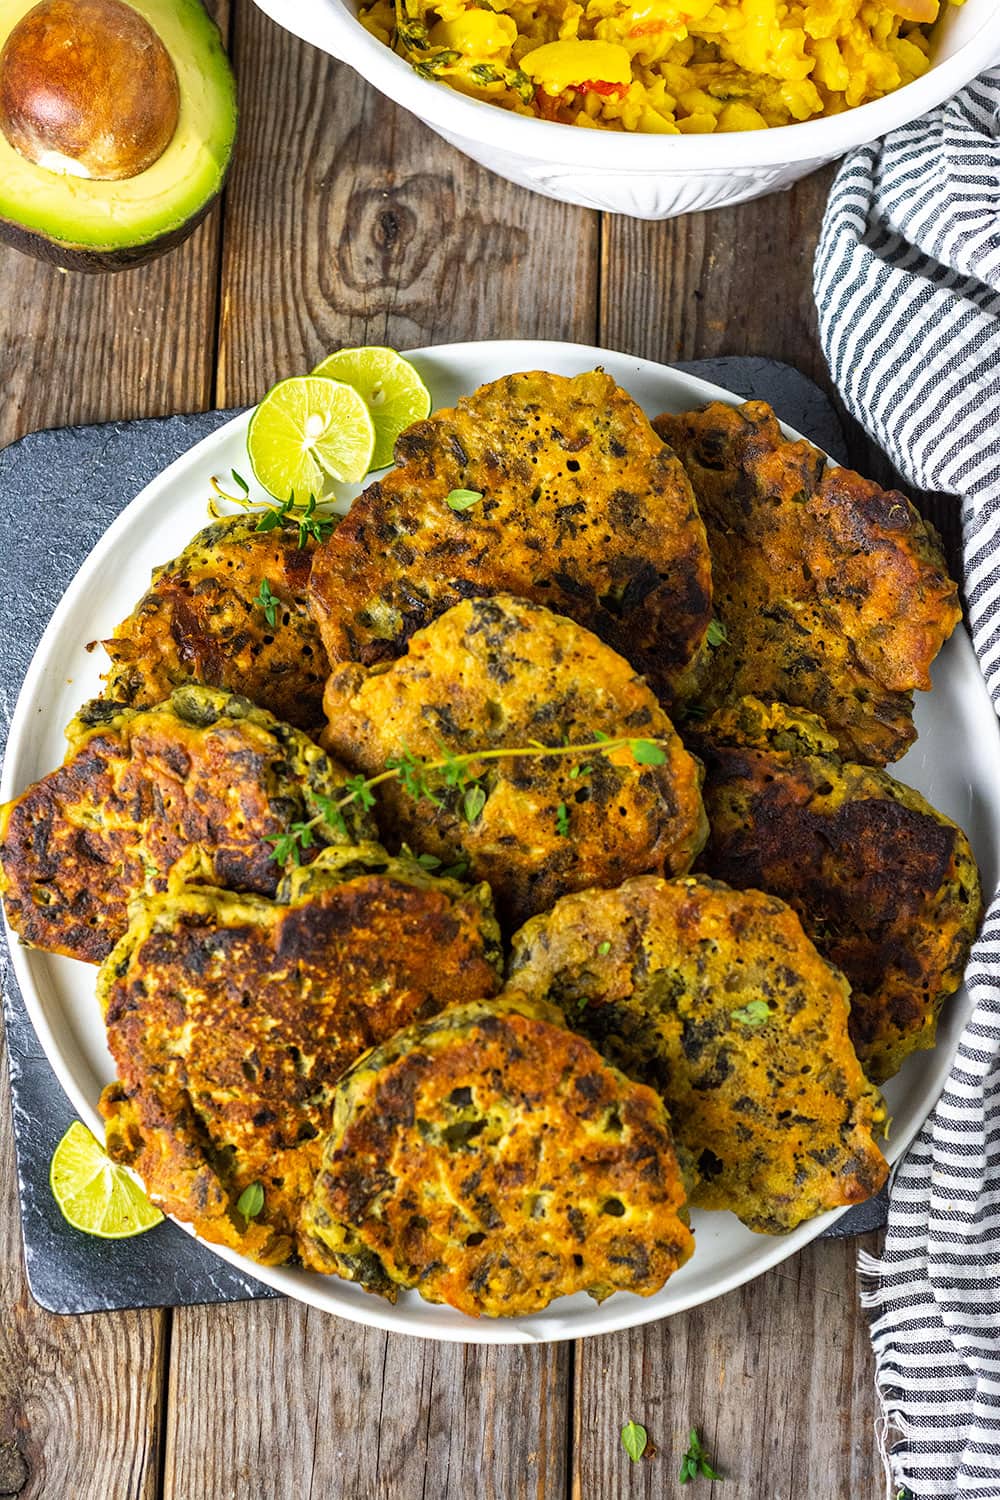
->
[0, 11, 225, 1500]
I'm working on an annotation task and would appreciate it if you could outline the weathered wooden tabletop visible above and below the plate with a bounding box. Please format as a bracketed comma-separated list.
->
[0, 0, 905, 1500]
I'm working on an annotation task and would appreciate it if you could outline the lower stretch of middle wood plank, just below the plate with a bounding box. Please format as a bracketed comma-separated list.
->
[163, 1302, 567, 1500]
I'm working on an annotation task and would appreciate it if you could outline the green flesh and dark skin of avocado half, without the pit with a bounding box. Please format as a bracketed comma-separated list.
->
[0, 0, 237, 273]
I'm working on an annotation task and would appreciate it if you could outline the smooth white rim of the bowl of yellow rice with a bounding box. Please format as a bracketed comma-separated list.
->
[255, 0, 1000, 167]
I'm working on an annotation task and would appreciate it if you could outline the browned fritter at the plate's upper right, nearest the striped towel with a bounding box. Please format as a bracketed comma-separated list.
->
[655, 401, 961, 765]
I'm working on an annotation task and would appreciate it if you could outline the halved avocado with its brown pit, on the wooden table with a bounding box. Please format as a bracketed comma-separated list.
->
[0, 0, 237, 272]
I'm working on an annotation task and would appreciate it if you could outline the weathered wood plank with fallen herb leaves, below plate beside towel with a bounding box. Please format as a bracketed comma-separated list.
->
[571, 1236, 883, 1500]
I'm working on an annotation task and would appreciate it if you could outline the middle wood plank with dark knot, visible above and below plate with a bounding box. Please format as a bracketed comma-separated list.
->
[163, 5, 597, 1500]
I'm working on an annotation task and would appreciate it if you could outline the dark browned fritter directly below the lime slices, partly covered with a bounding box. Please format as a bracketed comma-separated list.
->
[103, 516, 327, 729]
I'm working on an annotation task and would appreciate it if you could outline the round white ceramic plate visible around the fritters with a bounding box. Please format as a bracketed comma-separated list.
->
[0, 341, 1000, 1344]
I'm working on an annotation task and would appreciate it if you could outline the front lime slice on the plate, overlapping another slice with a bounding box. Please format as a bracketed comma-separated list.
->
[246, 375, 375, 506]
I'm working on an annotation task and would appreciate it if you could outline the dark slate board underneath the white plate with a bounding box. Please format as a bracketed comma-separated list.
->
[0, 359, 885, 1313]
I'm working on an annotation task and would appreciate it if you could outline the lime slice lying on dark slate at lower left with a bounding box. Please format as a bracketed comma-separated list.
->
[48, 1121, 163, 1239]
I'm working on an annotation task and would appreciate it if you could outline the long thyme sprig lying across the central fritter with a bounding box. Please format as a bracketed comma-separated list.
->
[267, 731, 667, 866]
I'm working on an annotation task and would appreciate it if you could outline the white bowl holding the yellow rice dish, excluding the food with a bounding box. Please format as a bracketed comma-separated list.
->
[256, 0, 1000, 219]
